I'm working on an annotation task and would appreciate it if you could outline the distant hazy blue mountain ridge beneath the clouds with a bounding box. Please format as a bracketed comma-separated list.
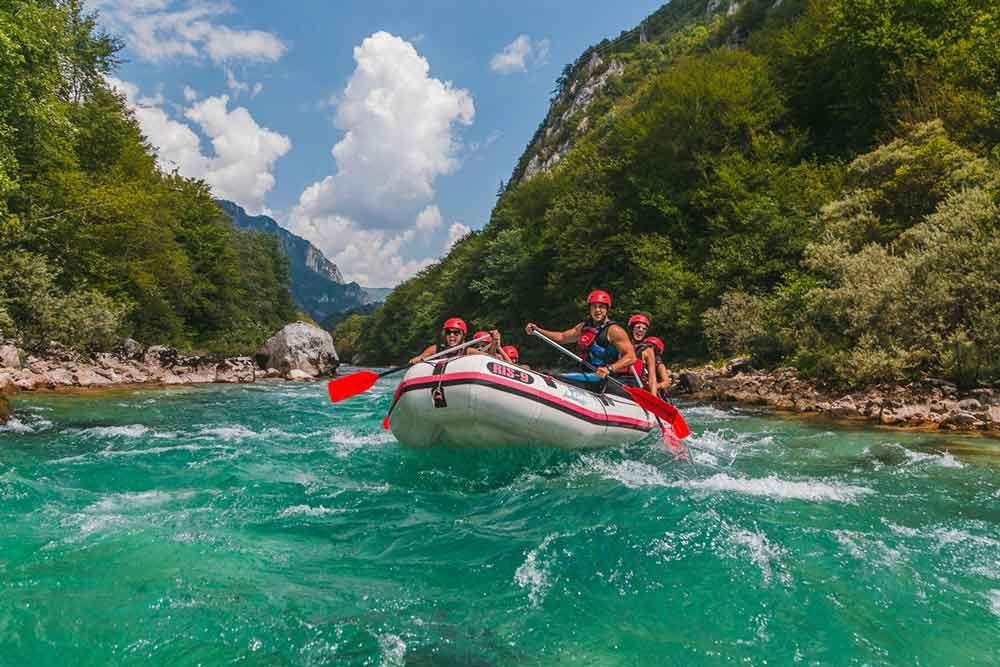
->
[216, 199, 391, 322]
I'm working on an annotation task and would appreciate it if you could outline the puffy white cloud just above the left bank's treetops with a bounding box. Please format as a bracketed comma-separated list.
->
[108, 77, 292, 212]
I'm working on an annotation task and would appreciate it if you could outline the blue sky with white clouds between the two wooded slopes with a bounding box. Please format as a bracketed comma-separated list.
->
[97, 0, 663, 286]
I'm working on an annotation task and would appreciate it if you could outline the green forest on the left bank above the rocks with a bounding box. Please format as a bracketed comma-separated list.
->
[0, 0, 296, 353]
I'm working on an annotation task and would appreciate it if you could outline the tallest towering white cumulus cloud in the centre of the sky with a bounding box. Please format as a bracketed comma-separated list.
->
[288, 32, 475, 285]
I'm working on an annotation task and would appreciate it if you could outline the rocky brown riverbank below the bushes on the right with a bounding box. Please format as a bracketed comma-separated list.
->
[673, 359, 1000, 435]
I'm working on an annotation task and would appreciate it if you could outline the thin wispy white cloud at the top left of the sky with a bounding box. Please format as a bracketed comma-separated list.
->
[92, 0, 288, 63]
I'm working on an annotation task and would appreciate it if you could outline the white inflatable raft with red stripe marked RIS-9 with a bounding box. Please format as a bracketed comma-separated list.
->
[390, 355, 656, 449]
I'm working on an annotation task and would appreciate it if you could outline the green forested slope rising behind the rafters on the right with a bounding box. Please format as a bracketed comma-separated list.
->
[346, 0, 1000, 386]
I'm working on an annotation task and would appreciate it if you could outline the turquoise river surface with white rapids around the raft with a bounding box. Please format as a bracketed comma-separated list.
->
[0, 379, 1000, 667]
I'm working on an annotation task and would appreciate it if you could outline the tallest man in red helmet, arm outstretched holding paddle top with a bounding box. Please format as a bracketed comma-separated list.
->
[524, 290, 635, 386]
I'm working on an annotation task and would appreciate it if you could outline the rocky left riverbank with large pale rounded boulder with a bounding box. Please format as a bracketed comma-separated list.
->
[0, 322, 339, 424]
